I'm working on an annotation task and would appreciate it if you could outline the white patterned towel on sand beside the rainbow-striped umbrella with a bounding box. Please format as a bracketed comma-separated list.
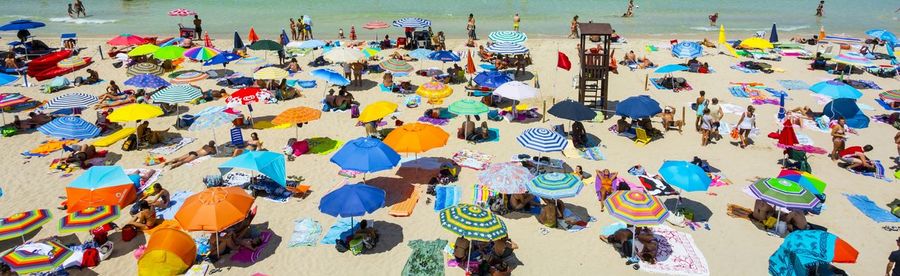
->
[641, 225, 709, 275]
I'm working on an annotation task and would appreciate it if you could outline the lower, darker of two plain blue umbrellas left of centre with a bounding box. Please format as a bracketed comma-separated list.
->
[319, 183, 385, 217]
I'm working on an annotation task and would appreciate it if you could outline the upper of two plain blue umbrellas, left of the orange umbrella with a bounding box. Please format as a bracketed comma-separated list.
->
[330, 137, 400, 173]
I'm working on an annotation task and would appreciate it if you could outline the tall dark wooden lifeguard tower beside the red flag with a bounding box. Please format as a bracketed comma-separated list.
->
[578, 23, 613, 109]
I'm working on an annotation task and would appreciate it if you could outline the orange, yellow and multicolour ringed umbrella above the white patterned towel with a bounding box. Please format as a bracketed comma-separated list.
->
[603, 191, 669, 226]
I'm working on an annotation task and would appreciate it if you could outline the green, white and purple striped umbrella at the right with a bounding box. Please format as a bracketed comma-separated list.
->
[750, 178, 820, 210]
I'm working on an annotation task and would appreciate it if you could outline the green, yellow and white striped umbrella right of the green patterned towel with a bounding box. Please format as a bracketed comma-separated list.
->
[438, 203, 507, 241]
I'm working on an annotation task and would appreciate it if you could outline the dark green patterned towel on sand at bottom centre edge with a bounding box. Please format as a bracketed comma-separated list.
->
[400, 239, 447, 276]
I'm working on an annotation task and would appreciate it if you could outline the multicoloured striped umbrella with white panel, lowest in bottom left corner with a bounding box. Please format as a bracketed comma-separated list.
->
[0, 240, 73, 275]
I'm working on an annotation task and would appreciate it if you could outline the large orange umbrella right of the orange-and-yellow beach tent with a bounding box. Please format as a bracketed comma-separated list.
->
[175, 187, 254, 232]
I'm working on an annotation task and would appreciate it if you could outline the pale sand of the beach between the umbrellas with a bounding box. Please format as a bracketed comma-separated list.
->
[0, 30, 900, 275]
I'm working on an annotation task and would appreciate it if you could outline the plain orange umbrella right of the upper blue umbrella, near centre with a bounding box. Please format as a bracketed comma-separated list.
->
[384, 123, 450, 153]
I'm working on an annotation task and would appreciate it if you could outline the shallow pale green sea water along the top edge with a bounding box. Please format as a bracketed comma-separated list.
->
[0, 0, 900, 40]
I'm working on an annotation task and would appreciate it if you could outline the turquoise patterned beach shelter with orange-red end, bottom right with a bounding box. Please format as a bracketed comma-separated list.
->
[769, 230, 859, 276]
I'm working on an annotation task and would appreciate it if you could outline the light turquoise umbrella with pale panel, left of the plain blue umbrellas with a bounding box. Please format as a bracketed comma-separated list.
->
[219, 150, 287, 186]
